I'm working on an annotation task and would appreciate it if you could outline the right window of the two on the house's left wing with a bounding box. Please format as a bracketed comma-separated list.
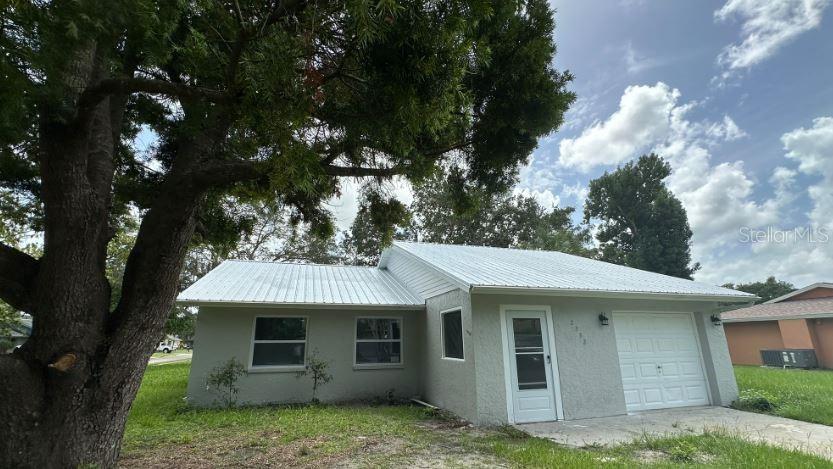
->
[355, 318, 402, 365]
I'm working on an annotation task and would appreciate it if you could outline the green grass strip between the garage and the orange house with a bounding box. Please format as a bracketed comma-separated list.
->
[735, 366, 833, 425]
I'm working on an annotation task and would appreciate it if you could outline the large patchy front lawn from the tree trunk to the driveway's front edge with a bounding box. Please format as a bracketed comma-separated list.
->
[120, 363, 833, 468]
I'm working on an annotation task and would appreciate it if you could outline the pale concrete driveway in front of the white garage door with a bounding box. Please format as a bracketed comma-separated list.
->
[517, 407, 833, 460]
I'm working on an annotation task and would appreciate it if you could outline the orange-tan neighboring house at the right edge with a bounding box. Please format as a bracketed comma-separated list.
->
[722, 283, 833, 368]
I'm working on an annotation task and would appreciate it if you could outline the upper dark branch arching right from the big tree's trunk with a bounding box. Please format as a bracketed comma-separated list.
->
[80, 78, 231, 107]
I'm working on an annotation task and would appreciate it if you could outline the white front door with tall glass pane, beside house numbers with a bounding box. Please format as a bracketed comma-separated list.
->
[506, 310, 556, 423]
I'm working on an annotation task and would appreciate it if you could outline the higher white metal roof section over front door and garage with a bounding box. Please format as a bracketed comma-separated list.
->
[380, 241, 757, 301]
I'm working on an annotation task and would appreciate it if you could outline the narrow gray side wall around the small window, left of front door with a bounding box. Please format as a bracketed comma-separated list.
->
[422, 290, 478, 421]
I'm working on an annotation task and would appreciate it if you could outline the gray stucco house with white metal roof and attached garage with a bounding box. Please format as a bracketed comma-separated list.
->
[178, 242, 755, 424]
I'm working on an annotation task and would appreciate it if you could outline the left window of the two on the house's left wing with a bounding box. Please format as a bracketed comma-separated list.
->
[252, 317, 307, 368]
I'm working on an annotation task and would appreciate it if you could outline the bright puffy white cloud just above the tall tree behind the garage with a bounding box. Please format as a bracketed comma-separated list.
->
[558, 82, 680, 172]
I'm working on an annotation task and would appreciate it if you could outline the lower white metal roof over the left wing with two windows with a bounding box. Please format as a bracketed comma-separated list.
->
[177, 260, 425, 308]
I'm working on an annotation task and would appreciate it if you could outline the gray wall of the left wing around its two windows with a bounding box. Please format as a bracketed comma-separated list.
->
[187, 306, 424, 406]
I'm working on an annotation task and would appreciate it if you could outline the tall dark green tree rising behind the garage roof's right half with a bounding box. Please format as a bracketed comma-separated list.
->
[584, 154, 700, 279]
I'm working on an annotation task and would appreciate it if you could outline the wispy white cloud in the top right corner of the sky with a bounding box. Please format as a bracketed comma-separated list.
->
[714, 0, 830, 81]
